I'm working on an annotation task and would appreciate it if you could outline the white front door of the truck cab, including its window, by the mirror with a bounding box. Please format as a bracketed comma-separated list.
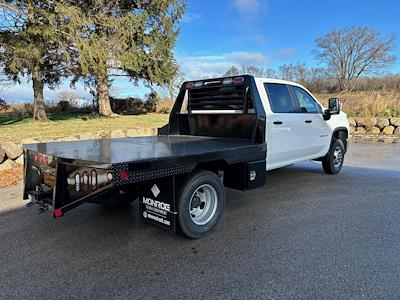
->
[289, 85, 331, 158]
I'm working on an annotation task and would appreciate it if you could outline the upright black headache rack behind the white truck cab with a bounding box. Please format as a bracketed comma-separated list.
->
[159, 75, 266, 144]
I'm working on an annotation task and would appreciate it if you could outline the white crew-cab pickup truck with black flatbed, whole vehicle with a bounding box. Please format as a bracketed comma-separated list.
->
[24, 75, 349, 238]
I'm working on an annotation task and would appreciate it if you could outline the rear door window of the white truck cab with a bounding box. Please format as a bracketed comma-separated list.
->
[264, 83, 294, 113]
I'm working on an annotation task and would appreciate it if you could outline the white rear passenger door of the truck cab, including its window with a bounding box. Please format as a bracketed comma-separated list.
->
[264, 83, 304, 169]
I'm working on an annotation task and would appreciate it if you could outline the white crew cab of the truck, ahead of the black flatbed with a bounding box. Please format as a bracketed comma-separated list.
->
[255, 78, 349, 170]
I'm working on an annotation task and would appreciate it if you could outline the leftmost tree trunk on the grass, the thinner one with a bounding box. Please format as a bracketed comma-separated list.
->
[32, 64, 48, 121]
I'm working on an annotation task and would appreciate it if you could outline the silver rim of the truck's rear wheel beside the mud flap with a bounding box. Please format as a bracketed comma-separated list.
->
[189, 184, 218, 225]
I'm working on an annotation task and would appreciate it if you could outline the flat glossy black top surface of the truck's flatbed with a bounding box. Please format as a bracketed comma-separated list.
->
[25, 135, 265, 164]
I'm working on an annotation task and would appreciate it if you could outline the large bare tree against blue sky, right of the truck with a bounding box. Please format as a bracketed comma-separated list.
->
[314, 27, 396, 91]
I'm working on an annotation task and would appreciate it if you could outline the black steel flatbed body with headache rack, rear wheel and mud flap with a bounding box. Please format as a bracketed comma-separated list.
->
[24, 76, 267, 238]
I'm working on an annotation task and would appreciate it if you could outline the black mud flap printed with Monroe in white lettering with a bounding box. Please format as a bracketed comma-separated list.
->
[139, 176, 177, 234]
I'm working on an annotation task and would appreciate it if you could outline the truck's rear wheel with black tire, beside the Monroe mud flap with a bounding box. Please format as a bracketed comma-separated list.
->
[177, 170, 225, 239]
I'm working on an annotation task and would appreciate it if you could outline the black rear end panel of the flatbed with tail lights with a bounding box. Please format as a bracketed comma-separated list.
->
[23, 150, 113, 217]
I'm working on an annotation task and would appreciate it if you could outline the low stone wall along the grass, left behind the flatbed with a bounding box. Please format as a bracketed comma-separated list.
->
[0, 128, 157, 172]
